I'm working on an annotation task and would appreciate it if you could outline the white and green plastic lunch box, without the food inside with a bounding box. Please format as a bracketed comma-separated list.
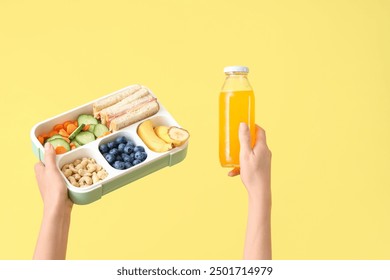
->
[30, 85, 188, 204]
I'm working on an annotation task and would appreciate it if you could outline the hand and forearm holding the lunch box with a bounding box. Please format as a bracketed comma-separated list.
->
[33, 143, 73, 260]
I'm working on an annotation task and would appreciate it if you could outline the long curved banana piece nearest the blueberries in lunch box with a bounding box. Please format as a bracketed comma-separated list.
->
[137, 120, 172, 153]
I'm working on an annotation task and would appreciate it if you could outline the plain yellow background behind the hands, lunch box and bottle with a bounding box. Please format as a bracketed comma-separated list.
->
[0, 0, 390, 259]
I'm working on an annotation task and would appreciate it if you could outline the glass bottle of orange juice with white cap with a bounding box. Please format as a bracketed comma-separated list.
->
[219, 66, 255, 167]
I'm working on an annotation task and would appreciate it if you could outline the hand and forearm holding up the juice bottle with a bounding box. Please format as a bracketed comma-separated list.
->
[228, 123, 272, 260]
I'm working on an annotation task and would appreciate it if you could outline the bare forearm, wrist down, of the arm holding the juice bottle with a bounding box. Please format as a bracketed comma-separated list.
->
[244, 184, 272, 259]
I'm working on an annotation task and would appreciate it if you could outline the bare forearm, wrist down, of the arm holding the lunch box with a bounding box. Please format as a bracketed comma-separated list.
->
[33, 208, 71, 260]
